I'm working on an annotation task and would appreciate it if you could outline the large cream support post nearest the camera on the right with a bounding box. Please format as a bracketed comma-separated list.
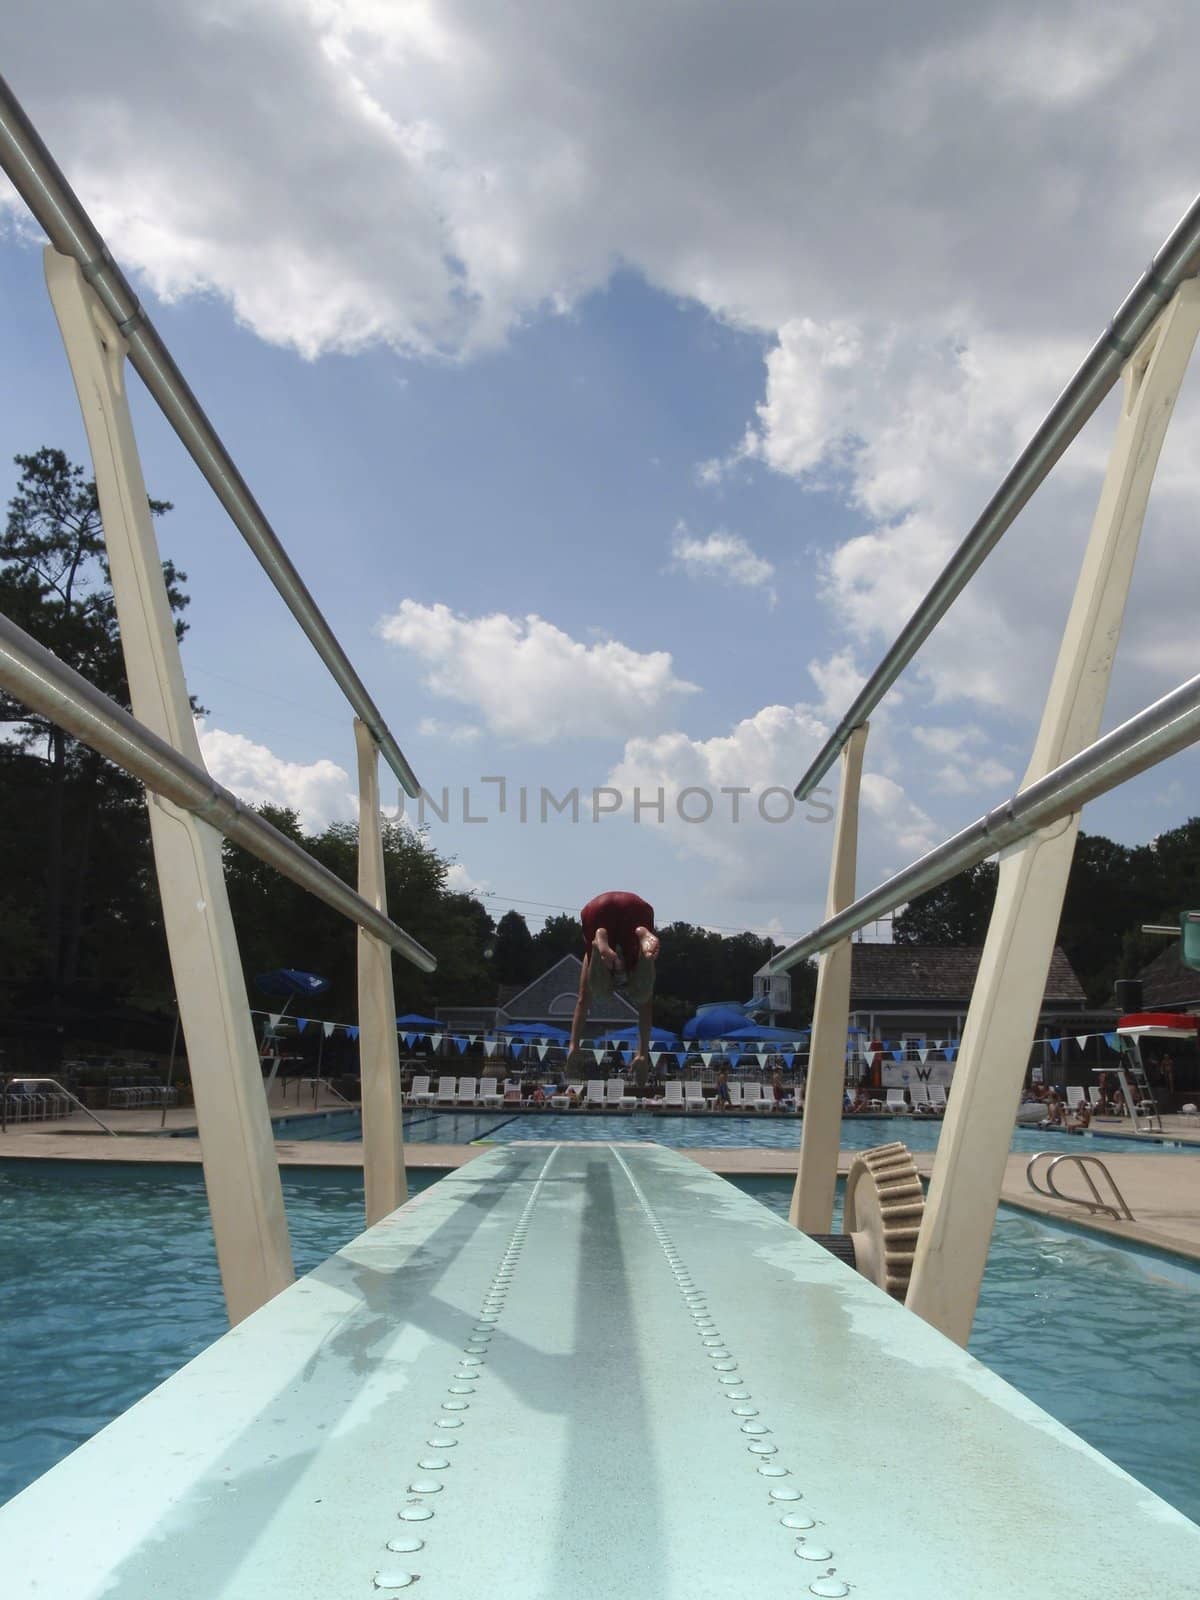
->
[906, 280, 1200, 1346]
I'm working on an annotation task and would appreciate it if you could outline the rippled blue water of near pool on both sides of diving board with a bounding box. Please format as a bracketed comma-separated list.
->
[0, 1158, 1200, 1520]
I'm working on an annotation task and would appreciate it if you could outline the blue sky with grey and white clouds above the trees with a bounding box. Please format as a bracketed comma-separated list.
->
[0, 0, 1200, 934]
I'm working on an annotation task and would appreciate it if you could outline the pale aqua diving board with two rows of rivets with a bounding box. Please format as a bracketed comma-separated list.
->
[0, 1144, 1200, 1600]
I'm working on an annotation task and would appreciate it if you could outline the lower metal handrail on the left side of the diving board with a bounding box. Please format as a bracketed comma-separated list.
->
[0, 614, 437, 973]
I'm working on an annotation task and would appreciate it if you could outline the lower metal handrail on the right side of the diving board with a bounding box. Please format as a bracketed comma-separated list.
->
[765, 674, 1200, 973]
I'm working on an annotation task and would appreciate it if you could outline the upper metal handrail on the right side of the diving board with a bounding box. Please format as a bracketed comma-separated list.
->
[795, 198, 1200, 800]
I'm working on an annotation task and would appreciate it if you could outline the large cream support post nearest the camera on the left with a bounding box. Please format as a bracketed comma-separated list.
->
[45, 246, 294, 1323]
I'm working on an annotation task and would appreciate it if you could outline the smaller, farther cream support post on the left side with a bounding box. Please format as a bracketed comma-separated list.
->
[354, 717, 408, 1227]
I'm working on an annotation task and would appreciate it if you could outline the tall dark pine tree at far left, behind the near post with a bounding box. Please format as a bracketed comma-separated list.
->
[0, 448, 187, 1049]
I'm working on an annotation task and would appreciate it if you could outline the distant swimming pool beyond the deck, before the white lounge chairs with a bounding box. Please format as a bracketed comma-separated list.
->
[265, 1110, 1195, 1155]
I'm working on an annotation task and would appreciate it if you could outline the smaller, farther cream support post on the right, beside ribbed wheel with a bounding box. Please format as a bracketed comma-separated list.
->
[787, 723, 867, 1234]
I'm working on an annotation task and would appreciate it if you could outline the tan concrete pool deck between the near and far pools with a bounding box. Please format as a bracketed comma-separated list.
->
[0, 1099, 1200, 1261]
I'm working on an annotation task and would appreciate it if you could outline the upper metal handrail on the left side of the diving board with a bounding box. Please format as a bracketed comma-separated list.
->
[0, 77, 421, 798]
